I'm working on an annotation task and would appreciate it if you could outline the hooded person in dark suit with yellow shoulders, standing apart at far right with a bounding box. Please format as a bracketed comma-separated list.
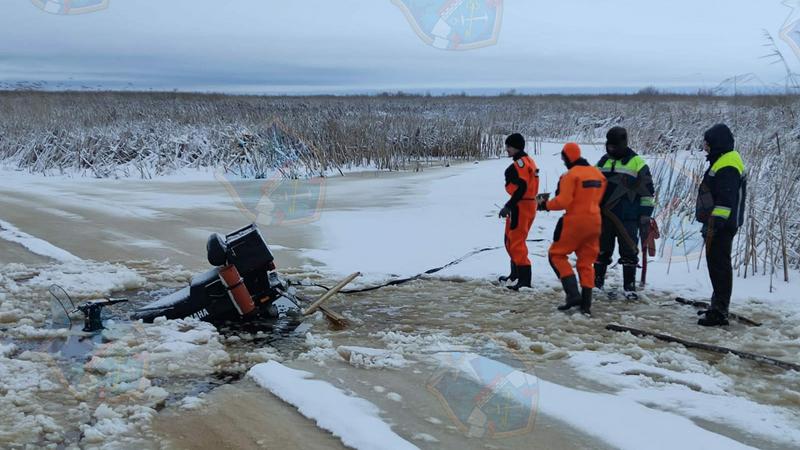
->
[696, 124, 747, 327]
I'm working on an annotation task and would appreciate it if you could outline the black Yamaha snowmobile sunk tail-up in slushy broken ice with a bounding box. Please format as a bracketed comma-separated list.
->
[131, 224, 299, 322]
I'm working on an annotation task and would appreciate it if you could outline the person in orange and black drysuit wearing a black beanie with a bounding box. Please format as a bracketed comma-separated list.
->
[500, 133, 539, 291]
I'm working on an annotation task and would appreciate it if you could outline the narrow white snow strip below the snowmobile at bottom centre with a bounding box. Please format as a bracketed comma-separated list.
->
[247, 361, 417, 450]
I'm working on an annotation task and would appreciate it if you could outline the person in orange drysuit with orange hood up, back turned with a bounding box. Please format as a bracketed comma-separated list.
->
[539, 142, 607, 315]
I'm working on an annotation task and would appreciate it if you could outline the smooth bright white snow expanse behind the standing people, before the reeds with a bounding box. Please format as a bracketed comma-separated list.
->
[307, 143, 800, 310]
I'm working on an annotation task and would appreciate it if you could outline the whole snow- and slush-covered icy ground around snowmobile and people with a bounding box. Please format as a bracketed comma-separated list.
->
[0, 144, 800, 449]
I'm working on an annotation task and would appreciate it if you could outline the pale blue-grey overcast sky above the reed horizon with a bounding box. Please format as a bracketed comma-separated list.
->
[0, 0, 800, 93]
